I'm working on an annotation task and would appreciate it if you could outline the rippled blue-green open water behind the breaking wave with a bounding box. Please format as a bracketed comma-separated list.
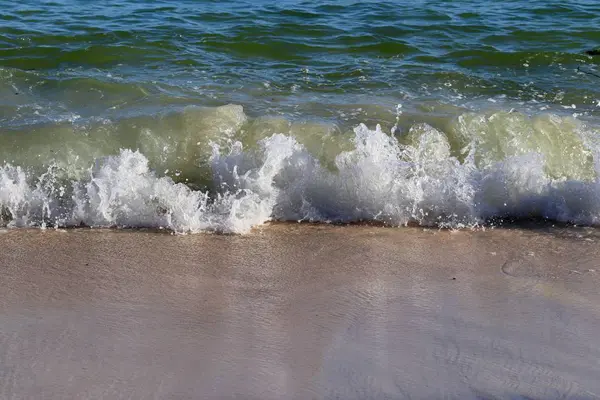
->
[0, 0, 600, 127]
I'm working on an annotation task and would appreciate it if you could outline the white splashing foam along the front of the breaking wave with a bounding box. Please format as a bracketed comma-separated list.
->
[0, 125, 600, 233]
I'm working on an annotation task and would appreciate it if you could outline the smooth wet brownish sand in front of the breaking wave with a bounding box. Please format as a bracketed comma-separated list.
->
[0, 224, 600, 399]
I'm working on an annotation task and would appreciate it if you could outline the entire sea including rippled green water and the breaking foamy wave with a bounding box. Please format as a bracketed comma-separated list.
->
[0, 0, 600, 232]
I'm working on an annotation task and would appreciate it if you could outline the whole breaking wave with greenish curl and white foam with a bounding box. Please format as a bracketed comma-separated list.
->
[0, 106, 600, 233]
